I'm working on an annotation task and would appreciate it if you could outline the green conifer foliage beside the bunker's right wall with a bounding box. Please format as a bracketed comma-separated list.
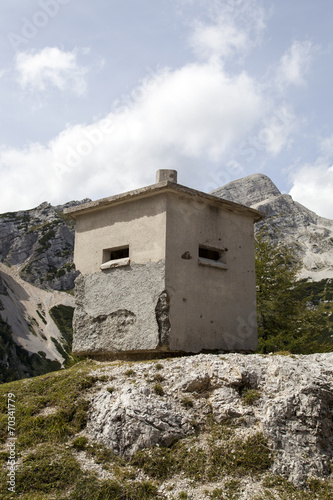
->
[256, 229, 333, 354]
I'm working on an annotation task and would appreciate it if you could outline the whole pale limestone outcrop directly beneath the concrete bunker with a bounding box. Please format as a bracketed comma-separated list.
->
[87, 353, 333, 486]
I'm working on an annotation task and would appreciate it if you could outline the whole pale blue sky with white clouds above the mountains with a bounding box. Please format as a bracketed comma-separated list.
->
[0, 0, 333, 218]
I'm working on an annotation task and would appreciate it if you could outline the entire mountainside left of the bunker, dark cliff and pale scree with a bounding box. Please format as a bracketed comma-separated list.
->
[0, 202, 85, 381]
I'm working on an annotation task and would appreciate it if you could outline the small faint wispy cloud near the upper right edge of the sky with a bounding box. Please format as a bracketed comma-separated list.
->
[276, 41, 316, 87]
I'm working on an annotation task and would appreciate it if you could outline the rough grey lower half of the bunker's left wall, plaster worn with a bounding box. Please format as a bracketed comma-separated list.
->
[73, 260, 169, 355]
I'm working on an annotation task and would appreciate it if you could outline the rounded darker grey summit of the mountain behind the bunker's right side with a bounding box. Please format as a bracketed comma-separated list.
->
[211, 174, 281, 206]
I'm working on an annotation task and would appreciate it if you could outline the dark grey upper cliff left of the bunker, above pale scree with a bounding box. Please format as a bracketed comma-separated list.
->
[0, 200, 86, 290]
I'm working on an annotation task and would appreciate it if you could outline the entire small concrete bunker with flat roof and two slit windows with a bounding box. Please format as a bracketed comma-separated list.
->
[67, 170, 262, 358]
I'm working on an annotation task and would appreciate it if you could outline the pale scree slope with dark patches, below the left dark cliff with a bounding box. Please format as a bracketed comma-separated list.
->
[0, 264, 74, 382]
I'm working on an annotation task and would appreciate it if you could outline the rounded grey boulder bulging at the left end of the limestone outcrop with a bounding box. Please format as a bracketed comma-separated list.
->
[87, 383, 191, 455]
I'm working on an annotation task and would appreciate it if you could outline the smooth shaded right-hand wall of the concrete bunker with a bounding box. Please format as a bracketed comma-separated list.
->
[166, 193, 257, 352]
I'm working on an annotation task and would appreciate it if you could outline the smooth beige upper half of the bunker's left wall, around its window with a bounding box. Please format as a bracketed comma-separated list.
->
[74, 195, 166, 274]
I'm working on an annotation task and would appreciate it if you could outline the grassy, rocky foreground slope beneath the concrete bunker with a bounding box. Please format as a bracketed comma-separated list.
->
[0, 353, 333, 500]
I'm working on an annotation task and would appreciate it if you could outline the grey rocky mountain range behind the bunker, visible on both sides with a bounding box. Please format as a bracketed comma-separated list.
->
[0, 174, 333, 382]
